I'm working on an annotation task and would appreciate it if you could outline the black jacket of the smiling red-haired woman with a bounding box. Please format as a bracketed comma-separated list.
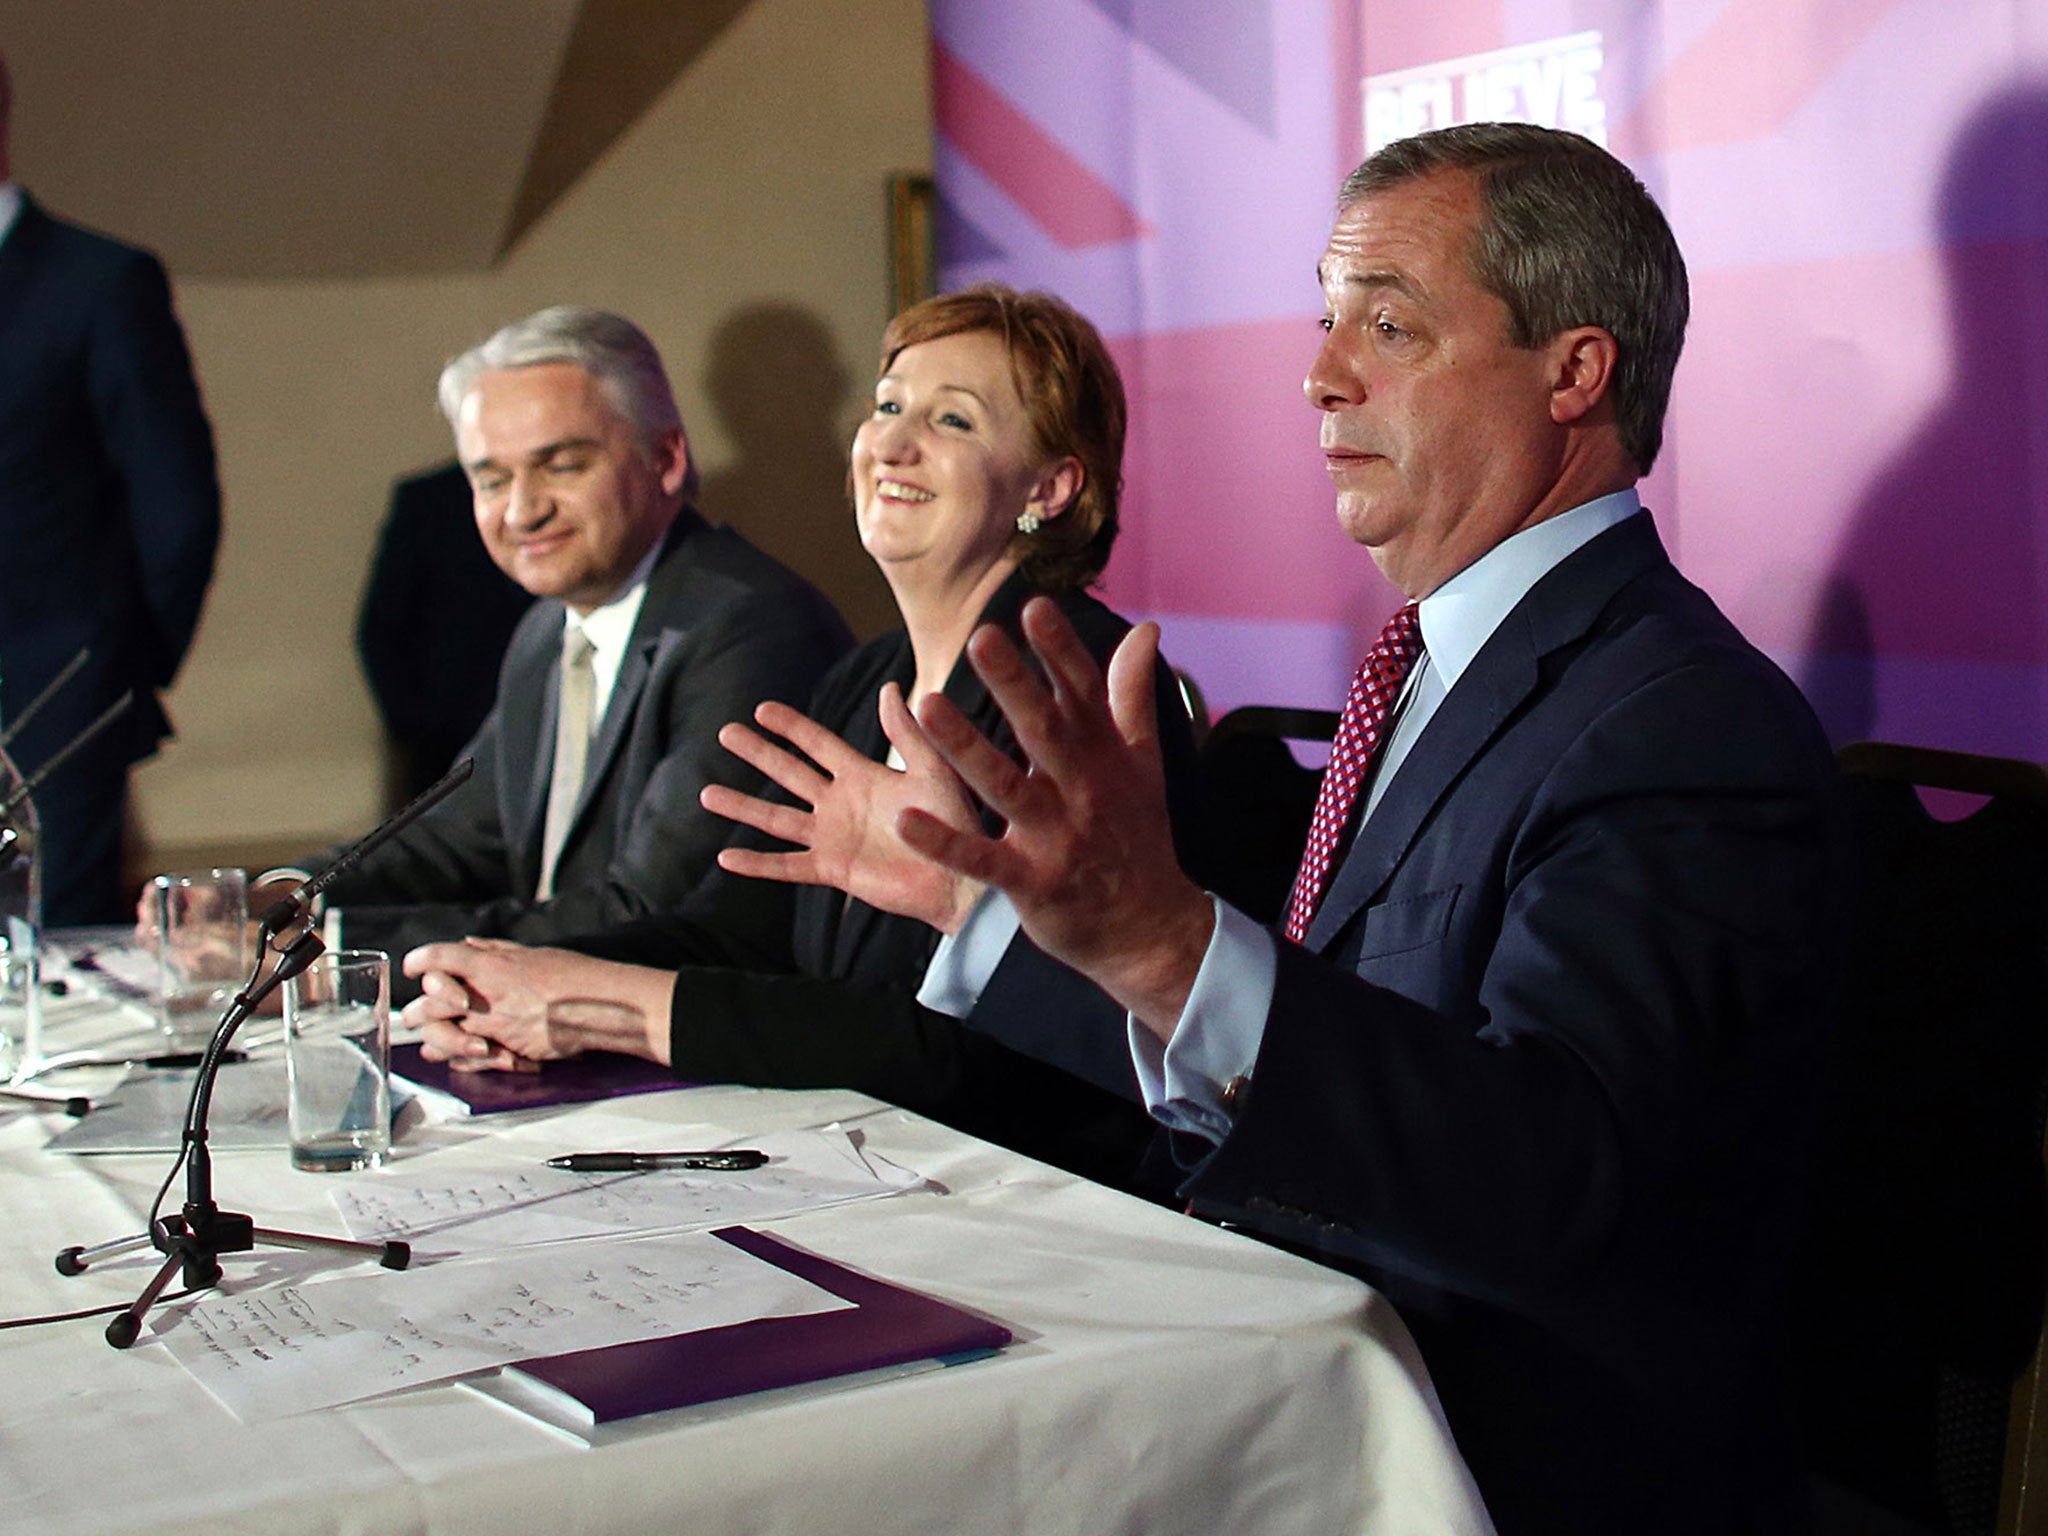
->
[573, 575, 1194, 1186]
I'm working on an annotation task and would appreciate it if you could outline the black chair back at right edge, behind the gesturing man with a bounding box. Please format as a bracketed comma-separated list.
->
[1792, 743, 2048, 1536]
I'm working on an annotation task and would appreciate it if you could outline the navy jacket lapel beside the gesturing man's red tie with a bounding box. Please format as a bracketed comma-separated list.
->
[1309, 512, 1667, 950]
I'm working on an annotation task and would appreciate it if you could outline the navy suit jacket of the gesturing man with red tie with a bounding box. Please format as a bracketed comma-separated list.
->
[971, 514, 1845, 1536]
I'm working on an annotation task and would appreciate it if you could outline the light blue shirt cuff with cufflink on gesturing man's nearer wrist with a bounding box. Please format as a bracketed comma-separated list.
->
[1128, 897, 1278, 1143]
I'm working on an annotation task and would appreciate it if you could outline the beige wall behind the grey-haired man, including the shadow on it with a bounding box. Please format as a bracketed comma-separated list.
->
[135, 0, 930, 858]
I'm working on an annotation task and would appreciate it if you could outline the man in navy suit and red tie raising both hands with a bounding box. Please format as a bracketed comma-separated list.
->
[733, 125, 1843, 1536]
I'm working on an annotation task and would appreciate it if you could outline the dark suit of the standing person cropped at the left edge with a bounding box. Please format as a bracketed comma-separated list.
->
[0, 197, 221, 924]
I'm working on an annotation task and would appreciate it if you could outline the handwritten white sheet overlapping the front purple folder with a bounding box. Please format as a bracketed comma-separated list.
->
[158, 1233, 852, 1423]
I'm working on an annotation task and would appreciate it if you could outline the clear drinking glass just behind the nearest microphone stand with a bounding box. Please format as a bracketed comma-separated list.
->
[285, 950, 391, 1174]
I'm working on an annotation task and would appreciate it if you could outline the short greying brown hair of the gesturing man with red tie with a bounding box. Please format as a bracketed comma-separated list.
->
[1337, 123, 1692, 473]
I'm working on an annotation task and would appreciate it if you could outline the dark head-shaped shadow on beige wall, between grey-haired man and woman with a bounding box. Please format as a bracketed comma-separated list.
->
[698, 303, 897, 639]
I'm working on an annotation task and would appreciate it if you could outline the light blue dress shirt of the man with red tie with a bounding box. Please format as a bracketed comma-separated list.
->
[918, 489, 1642, 1141]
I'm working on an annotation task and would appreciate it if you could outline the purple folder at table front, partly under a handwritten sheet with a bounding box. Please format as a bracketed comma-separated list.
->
[516, 1227, 1012, 1423]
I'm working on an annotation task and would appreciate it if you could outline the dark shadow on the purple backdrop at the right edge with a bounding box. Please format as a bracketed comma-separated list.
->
[1800, 84, 2048, 758]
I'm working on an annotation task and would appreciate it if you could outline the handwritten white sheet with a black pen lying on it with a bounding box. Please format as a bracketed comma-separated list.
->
[334, 1130, 924, 1253]
